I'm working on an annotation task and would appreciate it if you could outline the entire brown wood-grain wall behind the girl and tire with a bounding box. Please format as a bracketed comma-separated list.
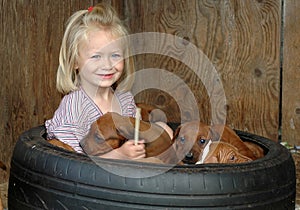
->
[0, 0, 300, 182]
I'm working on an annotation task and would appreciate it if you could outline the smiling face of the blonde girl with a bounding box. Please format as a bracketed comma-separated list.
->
[76, 30, 124, 90]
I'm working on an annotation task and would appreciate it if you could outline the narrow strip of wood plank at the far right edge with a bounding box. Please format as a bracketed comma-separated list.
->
[282, 0, 300, 145]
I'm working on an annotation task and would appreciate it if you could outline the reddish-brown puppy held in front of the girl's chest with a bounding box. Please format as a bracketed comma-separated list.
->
[80, 112, 173, 157]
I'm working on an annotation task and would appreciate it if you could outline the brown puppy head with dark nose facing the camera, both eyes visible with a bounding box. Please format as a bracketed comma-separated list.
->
[173, 121, 209, 164]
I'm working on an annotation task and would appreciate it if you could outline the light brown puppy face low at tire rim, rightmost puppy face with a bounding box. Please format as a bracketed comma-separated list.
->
[199, 141, 252, 163]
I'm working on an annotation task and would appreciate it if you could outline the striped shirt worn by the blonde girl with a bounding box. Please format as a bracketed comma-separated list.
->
[45, 88, 136, 153]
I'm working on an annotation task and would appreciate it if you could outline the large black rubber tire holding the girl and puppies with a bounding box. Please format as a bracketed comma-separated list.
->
[8, 126, 296, 210]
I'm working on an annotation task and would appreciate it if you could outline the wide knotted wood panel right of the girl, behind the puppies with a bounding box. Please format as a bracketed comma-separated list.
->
[125, 0, 281, 140]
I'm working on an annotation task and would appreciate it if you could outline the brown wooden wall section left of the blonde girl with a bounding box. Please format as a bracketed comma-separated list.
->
[0, 0, 91, 181]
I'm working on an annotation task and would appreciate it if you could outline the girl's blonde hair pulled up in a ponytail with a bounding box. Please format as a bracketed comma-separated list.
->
[56, 3, 134, 94]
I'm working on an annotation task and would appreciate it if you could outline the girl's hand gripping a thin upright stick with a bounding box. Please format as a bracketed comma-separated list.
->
[115, 140, 146, 159]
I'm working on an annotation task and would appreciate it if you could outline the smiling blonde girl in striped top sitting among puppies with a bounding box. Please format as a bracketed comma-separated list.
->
[45, 4, 145, 159]
